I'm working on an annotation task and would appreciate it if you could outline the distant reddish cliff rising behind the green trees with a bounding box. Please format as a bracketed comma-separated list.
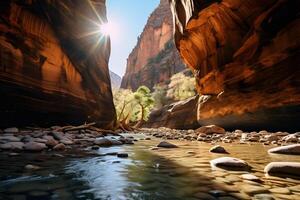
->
[121, 0, 185, 90]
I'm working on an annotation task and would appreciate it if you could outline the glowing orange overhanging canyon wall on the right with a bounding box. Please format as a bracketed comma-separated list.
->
[170, 0, 300, 129]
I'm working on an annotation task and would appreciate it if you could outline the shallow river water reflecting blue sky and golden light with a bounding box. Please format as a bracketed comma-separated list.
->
[0, 135, 300, 200]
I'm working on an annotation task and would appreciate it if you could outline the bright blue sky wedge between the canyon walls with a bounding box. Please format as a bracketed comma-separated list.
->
[106, 0, 159, 77]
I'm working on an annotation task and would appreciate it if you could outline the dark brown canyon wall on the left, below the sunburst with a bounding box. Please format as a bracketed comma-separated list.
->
[0, 0, 115, 128]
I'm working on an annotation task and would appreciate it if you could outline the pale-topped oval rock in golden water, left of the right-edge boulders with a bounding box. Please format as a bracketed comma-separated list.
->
[210, 157, 251, 171]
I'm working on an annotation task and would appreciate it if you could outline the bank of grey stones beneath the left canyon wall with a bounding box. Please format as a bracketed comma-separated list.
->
[0, 124, 133, 155]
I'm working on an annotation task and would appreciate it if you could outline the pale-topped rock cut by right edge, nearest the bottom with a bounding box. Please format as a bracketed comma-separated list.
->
[264, 162, 300, 179]
